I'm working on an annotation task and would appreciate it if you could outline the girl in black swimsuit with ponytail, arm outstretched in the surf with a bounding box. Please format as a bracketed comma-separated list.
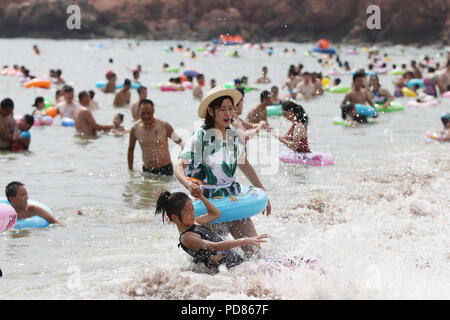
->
[155, 189, 269, 273]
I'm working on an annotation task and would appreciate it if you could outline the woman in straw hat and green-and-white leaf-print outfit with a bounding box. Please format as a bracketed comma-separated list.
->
[175, 86, 271, 254]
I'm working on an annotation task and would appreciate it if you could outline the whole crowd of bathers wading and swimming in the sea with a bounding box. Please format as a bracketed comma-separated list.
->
[0, 41, 450, 271]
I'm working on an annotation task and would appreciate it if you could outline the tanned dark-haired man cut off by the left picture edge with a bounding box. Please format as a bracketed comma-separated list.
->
[0, 98, 20, 151]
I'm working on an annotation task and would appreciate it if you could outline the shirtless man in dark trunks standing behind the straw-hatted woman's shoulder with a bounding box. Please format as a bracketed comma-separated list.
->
[128, 99, 184, 176]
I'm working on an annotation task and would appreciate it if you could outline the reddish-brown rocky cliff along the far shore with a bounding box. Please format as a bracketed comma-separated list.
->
[0, 0, 450, 45]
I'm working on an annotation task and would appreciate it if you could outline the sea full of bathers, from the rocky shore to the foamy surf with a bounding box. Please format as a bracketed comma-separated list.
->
[0, 39, 450, 300]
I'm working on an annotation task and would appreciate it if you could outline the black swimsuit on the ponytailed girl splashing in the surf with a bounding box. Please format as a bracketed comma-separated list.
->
[178, 224, 244, 272]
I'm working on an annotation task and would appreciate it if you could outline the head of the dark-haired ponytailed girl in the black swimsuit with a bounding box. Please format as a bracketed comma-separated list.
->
[155, 191, 195, 225]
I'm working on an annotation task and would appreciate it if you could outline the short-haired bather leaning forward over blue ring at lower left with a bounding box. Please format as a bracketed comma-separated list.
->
[6, 181, 59, 223]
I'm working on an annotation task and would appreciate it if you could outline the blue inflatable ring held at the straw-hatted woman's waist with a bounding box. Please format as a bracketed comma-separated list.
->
[191, 186, 269, 223]
